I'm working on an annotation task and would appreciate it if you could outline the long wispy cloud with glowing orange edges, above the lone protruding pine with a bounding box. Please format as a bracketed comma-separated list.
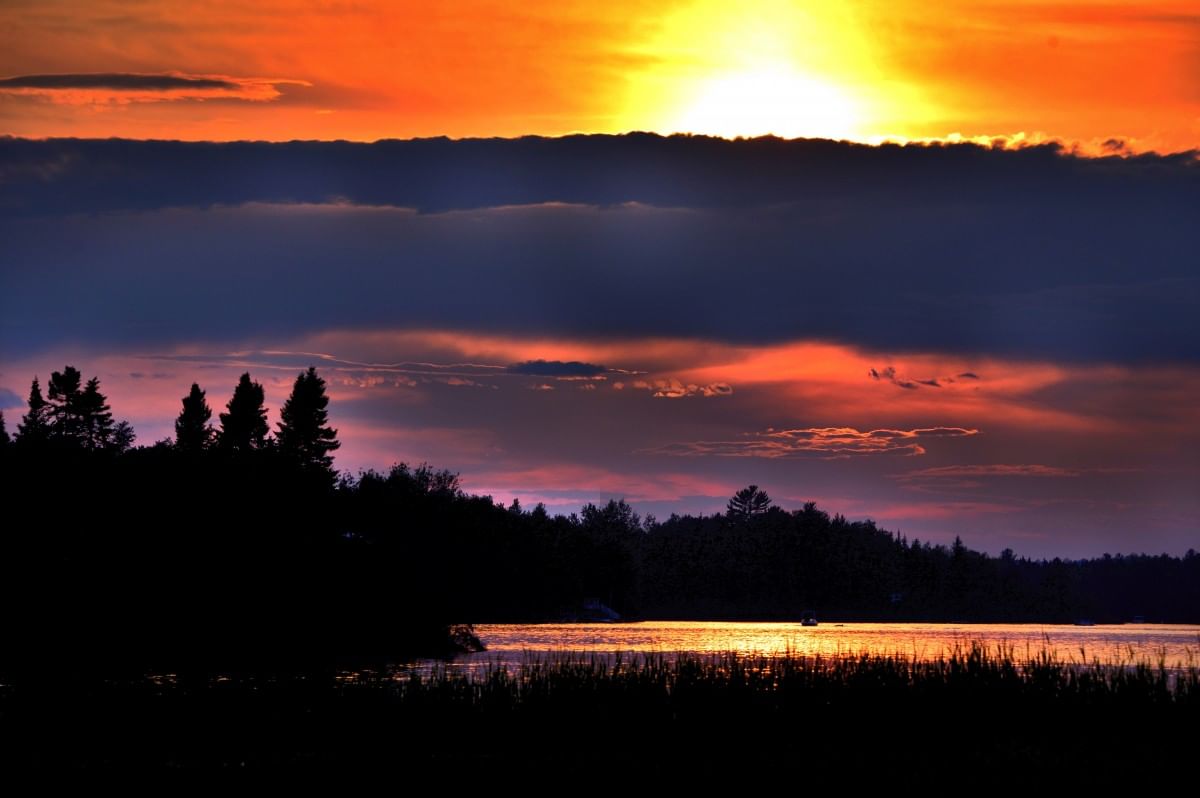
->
[643, 427, 979, 458]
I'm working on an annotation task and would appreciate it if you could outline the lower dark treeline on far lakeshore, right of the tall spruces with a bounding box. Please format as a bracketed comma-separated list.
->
[360, 482, 1200, 623]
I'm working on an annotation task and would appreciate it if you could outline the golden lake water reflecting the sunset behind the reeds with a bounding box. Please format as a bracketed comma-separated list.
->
[444, 620, 1200, 670]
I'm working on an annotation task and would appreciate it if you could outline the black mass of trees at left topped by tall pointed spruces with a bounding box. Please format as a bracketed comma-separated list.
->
[0, 367, 467, 678]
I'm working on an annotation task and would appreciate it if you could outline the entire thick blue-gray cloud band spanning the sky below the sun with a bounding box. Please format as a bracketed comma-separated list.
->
[0, 136, 1200, 364]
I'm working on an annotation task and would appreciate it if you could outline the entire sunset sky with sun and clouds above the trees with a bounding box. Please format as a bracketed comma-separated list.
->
[0, 0, 1200, 557]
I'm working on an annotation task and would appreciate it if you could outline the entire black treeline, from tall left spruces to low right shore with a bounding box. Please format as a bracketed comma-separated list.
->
[0, 367, 1200, 667]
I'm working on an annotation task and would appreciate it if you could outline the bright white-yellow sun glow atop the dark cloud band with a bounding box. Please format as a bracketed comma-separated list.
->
[625, 0, 881, 139]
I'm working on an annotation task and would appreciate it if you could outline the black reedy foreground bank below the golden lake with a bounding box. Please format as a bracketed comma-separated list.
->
[0, 647, 1200, 781]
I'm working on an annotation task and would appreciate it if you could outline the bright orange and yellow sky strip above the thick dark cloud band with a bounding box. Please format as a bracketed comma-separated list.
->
[7, 0, 1200, 150]
